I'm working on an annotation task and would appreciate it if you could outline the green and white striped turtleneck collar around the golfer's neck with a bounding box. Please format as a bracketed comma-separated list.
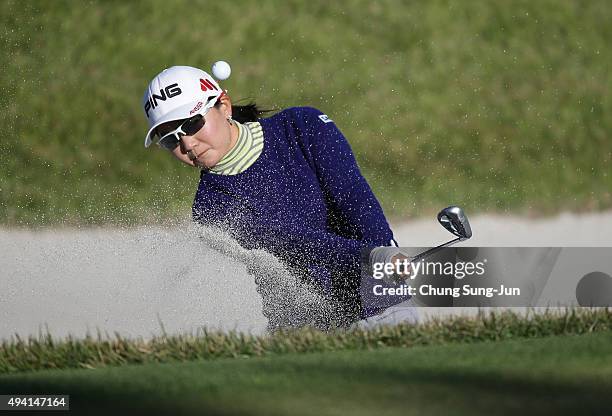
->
[210, 121, 263, 175]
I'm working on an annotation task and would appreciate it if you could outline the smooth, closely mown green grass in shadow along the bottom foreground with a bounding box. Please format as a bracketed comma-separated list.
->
[0, 332, 612, 416]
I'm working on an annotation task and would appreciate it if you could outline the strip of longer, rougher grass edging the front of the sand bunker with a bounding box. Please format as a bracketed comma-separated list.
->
[0, 308, 612, 374]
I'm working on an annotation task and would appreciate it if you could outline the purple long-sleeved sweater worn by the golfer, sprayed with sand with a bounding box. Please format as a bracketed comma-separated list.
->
[193, 107, 393, 313]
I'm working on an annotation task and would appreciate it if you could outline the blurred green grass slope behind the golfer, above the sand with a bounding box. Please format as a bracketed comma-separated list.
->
[0, 0, 612, 225]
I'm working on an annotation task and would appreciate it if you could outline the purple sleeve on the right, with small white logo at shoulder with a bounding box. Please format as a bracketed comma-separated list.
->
[299, 107, 396, 246]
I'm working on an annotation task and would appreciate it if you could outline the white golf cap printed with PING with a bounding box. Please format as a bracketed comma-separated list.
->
[142, 66, 223, 147]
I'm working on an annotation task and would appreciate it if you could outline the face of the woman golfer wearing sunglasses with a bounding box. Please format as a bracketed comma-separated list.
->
[157, 95, 238, 169]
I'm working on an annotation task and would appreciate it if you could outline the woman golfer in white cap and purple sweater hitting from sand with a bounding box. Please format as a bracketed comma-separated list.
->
[143, 66, 412, 325]
